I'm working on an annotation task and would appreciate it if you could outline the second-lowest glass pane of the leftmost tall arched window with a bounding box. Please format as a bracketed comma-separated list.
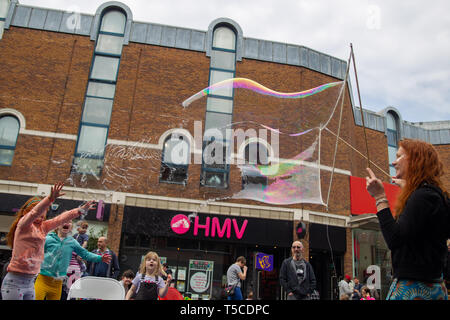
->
[77, 125, 108, 156]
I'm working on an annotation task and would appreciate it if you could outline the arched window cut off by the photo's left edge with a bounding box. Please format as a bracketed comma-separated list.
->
[0, 116, 20, 166]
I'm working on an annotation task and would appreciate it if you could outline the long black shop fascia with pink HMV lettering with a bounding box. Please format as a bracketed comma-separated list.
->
[122, 206, 294, 247]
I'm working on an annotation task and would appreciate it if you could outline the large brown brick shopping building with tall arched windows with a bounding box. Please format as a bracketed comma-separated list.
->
[0, 0, 450, 299]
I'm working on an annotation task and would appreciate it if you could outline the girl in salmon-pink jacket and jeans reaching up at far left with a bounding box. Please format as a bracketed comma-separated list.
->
[2, 182, 90, 300]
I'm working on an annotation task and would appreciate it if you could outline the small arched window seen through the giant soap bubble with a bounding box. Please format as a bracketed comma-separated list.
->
[242, 142, 269, 189]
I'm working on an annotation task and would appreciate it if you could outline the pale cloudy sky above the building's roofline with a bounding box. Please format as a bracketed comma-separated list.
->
[19, 0, 450, 122]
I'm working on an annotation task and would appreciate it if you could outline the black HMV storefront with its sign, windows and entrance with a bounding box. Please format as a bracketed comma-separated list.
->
[119, 207, 293, 299]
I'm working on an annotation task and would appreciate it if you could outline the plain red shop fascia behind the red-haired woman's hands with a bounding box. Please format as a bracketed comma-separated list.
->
[350, 176, 400, 215]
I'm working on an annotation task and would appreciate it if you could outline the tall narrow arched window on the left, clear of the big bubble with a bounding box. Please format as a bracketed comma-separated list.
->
[72, 9, 126, 175]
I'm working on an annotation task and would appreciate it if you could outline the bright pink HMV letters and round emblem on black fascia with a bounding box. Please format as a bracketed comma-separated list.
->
[170, 214, 248, 239]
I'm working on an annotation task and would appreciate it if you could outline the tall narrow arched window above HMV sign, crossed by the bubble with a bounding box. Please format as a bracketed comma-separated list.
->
[200, 25, 236, 188]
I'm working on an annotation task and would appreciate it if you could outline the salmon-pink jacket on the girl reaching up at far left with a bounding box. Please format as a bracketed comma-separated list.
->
[8, 197, 80, 275]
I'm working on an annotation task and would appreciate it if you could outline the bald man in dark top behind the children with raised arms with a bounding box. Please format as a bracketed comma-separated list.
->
[87, 237, 120, 279]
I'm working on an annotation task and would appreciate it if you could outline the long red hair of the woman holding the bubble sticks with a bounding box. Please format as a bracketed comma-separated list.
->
[394, 139, 448, 219]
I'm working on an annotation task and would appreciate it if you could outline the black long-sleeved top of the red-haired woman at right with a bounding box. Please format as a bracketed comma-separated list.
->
[377, 183, 450, 282]
